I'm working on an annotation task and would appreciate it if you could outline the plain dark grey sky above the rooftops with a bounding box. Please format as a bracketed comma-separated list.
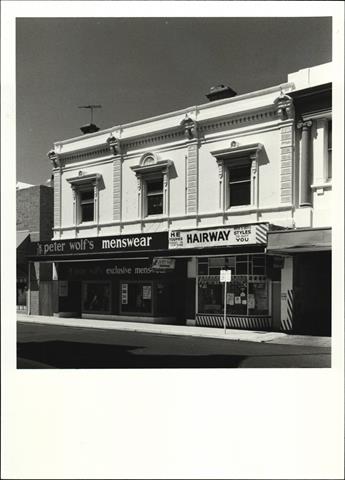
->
[16, 16, 332, 184]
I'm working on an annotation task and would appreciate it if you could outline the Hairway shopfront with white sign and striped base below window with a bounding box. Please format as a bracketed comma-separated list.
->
[169, 223, 272, 330]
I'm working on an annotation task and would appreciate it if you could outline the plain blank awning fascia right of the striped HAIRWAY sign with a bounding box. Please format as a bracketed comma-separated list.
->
[267, 228, 332, 254]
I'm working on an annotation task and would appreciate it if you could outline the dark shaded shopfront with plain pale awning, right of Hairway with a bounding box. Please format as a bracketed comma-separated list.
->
[267, 227, 332, 336]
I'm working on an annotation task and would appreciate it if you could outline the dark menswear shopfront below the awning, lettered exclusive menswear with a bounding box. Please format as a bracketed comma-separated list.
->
[56, 258, 186, 323]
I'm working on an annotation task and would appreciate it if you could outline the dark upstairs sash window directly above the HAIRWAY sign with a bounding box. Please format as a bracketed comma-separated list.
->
[229, 164, 250, 207]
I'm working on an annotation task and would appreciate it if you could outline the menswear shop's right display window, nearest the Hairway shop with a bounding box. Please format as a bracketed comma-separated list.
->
[120, 282, 152, 314]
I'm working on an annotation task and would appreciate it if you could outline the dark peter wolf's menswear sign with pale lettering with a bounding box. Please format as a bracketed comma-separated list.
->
[33, 232, 168, 257]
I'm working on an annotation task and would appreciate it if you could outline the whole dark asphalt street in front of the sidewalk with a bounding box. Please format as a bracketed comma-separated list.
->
[17, 318, 331, 369]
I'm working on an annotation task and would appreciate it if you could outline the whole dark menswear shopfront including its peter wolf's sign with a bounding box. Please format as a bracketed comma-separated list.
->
[31, 232, 188, 323]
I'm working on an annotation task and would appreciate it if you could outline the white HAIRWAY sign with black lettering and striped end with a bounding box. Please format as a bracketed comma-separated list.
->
[169, 223, 269, 249]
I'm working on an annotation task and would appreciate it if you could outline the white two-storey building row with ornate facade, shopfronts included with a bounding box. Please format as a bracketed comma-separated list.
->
[30, 64, 332, 334]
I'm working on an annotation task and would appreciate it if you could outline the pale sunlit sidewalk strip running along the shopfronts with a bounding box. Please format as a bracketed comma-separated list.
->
[17, 313, 331, 348]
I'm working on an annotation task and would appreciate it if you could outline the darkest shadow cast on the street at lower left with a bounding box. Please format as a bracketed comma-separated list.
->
[17, 341, 246, 369]
